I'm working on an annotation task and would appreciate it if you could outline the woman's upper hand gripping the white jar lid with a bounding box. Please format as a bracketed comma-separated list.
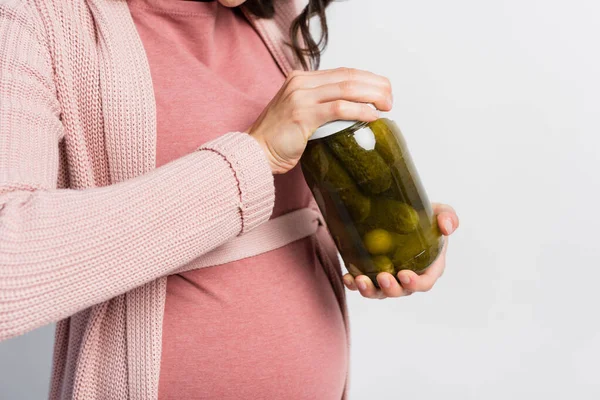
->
[247, 68, 392, 174]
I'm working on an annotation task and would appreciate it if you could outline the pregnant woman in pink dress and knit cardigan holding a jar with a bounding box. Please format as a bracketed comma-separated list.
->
[0, 0, 458, 400]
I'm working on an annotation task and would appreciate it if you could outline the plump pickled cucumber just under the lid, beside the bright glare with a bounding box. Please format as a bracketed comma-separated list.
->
[327, 132, 392, 194]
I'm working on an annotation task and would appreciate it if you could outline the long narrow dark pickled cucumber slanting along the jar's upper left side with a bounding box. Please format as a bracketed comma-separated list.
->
[303, 143, 371, 222]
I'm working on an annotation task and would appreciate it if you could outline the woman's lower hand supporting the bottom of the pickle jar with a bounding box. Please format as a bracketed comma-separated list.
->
[344, 204, 459, 299]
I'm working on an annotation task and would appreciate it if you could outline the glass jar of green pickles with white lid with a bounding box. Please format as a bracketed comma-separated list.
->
[300, 118, 443, 286]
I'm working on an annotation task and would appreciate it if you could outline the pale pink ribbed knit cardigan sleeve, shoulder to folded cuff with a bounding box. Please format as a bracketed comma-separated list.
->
[0, 0, 274, 340]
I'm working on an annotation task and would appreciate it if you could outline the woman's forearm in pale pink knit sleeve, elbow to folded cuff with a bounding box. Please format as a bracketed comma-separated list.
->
[0, 133, 274, 340]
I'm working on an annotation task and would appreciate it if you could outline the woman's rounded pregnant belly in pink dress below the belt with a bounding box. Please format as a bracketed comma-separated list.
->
[159, 238, 348, 400]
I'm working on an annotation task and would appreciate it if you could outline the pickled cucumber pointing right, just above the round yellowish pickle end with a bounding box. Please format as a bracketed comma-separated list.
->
[363, 198, 419, 233]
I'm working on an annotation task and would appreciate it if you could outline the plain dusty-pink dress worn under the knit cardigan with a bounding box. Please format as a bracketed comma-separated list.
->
[129, 0, 348, 400]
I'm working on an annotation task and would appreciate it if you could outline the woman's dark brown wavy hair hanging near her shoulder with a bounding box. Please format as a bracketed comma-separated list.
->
[244, 0, 333, 69]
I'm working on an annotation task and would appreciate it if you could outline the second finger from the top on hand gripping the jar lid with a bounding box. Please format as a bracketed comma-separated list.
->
[307, 81, 392, 111]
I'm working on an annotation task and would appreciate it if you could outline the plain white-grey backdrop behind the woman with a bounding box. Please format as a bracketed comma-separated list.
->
[0, 0, 600, 400]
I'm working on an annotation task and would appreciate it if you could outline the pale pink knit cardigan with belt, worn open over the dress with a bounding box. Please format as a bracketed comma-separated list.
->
[0, 0, 346, 400]
